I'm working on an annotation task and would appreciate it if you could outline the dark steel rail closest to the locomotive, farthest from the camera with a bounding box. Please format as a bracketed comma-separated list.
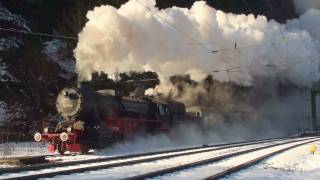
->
[0, 137, 297, 175]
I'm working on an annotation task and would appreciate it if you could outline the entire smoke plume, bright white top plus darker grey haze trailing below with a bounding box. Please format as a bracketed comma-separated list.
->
[74, 0, 320, 143]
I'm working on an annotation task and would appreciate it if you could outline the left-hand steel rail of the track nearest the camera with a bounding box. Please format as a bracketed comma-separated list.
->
[123, 137, 319, 180]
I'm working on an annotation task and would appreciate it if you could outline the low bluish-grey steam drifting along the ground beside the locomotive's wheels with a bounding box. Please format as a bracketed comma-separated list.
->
[97, 124, 252, 155]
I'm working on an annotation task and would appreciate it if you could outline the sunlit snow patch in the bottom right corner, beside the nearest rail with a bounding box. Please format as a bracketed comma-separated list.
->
[225, 141, 320, 180]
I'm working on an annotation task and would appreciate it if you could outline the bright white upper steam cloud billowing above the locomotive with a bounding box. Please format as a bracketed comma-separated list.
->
[74, 0, 320, 86]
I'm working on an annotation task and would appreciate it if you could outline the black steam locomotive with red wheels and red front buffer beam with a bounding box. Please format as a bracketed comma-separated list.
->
[34, 87, 190, 154]
